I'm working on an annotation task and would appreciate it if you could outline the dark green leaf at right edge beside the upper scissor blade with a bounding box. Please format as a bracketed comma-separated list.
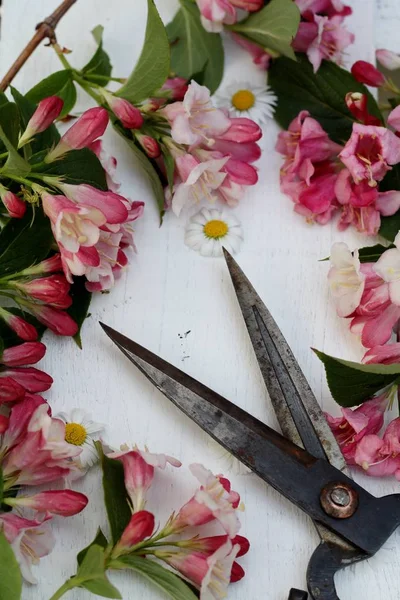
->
[314, 350, 400, 407]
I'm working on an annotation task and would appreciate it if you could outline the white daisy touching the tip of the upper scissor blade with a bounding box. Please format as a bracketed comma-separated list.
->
[185, 208, 243, 256]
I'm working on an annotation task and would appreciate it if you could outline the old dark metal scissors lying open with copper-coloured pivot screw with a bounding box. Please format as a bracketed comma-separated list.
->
[101, 251, 400, 600]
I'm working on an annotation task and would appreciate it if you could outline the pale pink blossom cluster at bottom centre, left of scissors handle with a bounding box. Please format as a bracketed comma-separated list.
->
[109, 447, 250, 600]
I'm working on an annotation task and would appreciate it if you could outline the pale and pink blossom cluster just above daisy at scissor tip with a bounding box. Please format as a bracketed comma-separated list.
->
[160, 81, 262, 215]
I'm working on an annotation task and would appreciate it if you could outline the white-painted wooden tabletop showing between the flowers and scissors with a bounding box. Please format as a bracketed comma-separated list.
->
[0, 0, 400, 600]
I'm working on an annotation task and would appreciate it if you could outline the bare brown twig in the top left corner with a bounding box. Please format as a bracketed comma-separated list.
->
[0, 0, 77, 92]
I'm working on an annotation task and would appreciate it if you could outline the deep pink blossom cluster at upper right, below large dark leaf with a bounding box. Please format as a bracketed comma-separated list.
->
[276, 98, 400, 235]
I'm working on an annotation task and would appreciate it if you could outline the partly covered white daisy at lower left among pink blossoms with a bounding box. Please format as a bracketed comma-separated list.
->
[56, 408, 104, 470]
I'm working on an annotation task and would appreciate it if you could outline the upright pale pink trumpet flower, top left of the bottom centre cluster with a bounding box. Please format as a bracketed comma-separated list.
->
[109, 449, 181, 513]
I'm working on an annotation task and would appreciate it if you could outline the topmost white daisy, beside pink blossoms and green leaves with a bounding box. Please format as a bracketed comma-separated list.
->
[214, 82, 277, 124]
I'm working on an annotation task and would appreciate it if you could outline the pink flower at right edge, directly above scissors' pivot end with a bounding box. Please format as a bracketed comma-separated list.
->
[355, 418, 400, 480]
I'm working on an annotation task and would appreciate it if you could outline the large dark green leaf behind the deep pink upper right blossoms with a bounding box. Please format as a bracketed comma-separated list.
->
[268, 54, 382, 144]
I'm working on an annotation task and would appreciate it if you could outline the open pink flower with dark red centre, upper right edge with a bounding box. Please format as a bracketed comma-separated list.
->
[339, 123, 400, 187]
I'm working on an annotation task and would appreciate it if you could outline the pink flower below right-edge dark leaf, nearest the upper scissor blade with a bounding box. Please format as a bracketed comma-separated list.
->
[325, 393, 388, 465]
